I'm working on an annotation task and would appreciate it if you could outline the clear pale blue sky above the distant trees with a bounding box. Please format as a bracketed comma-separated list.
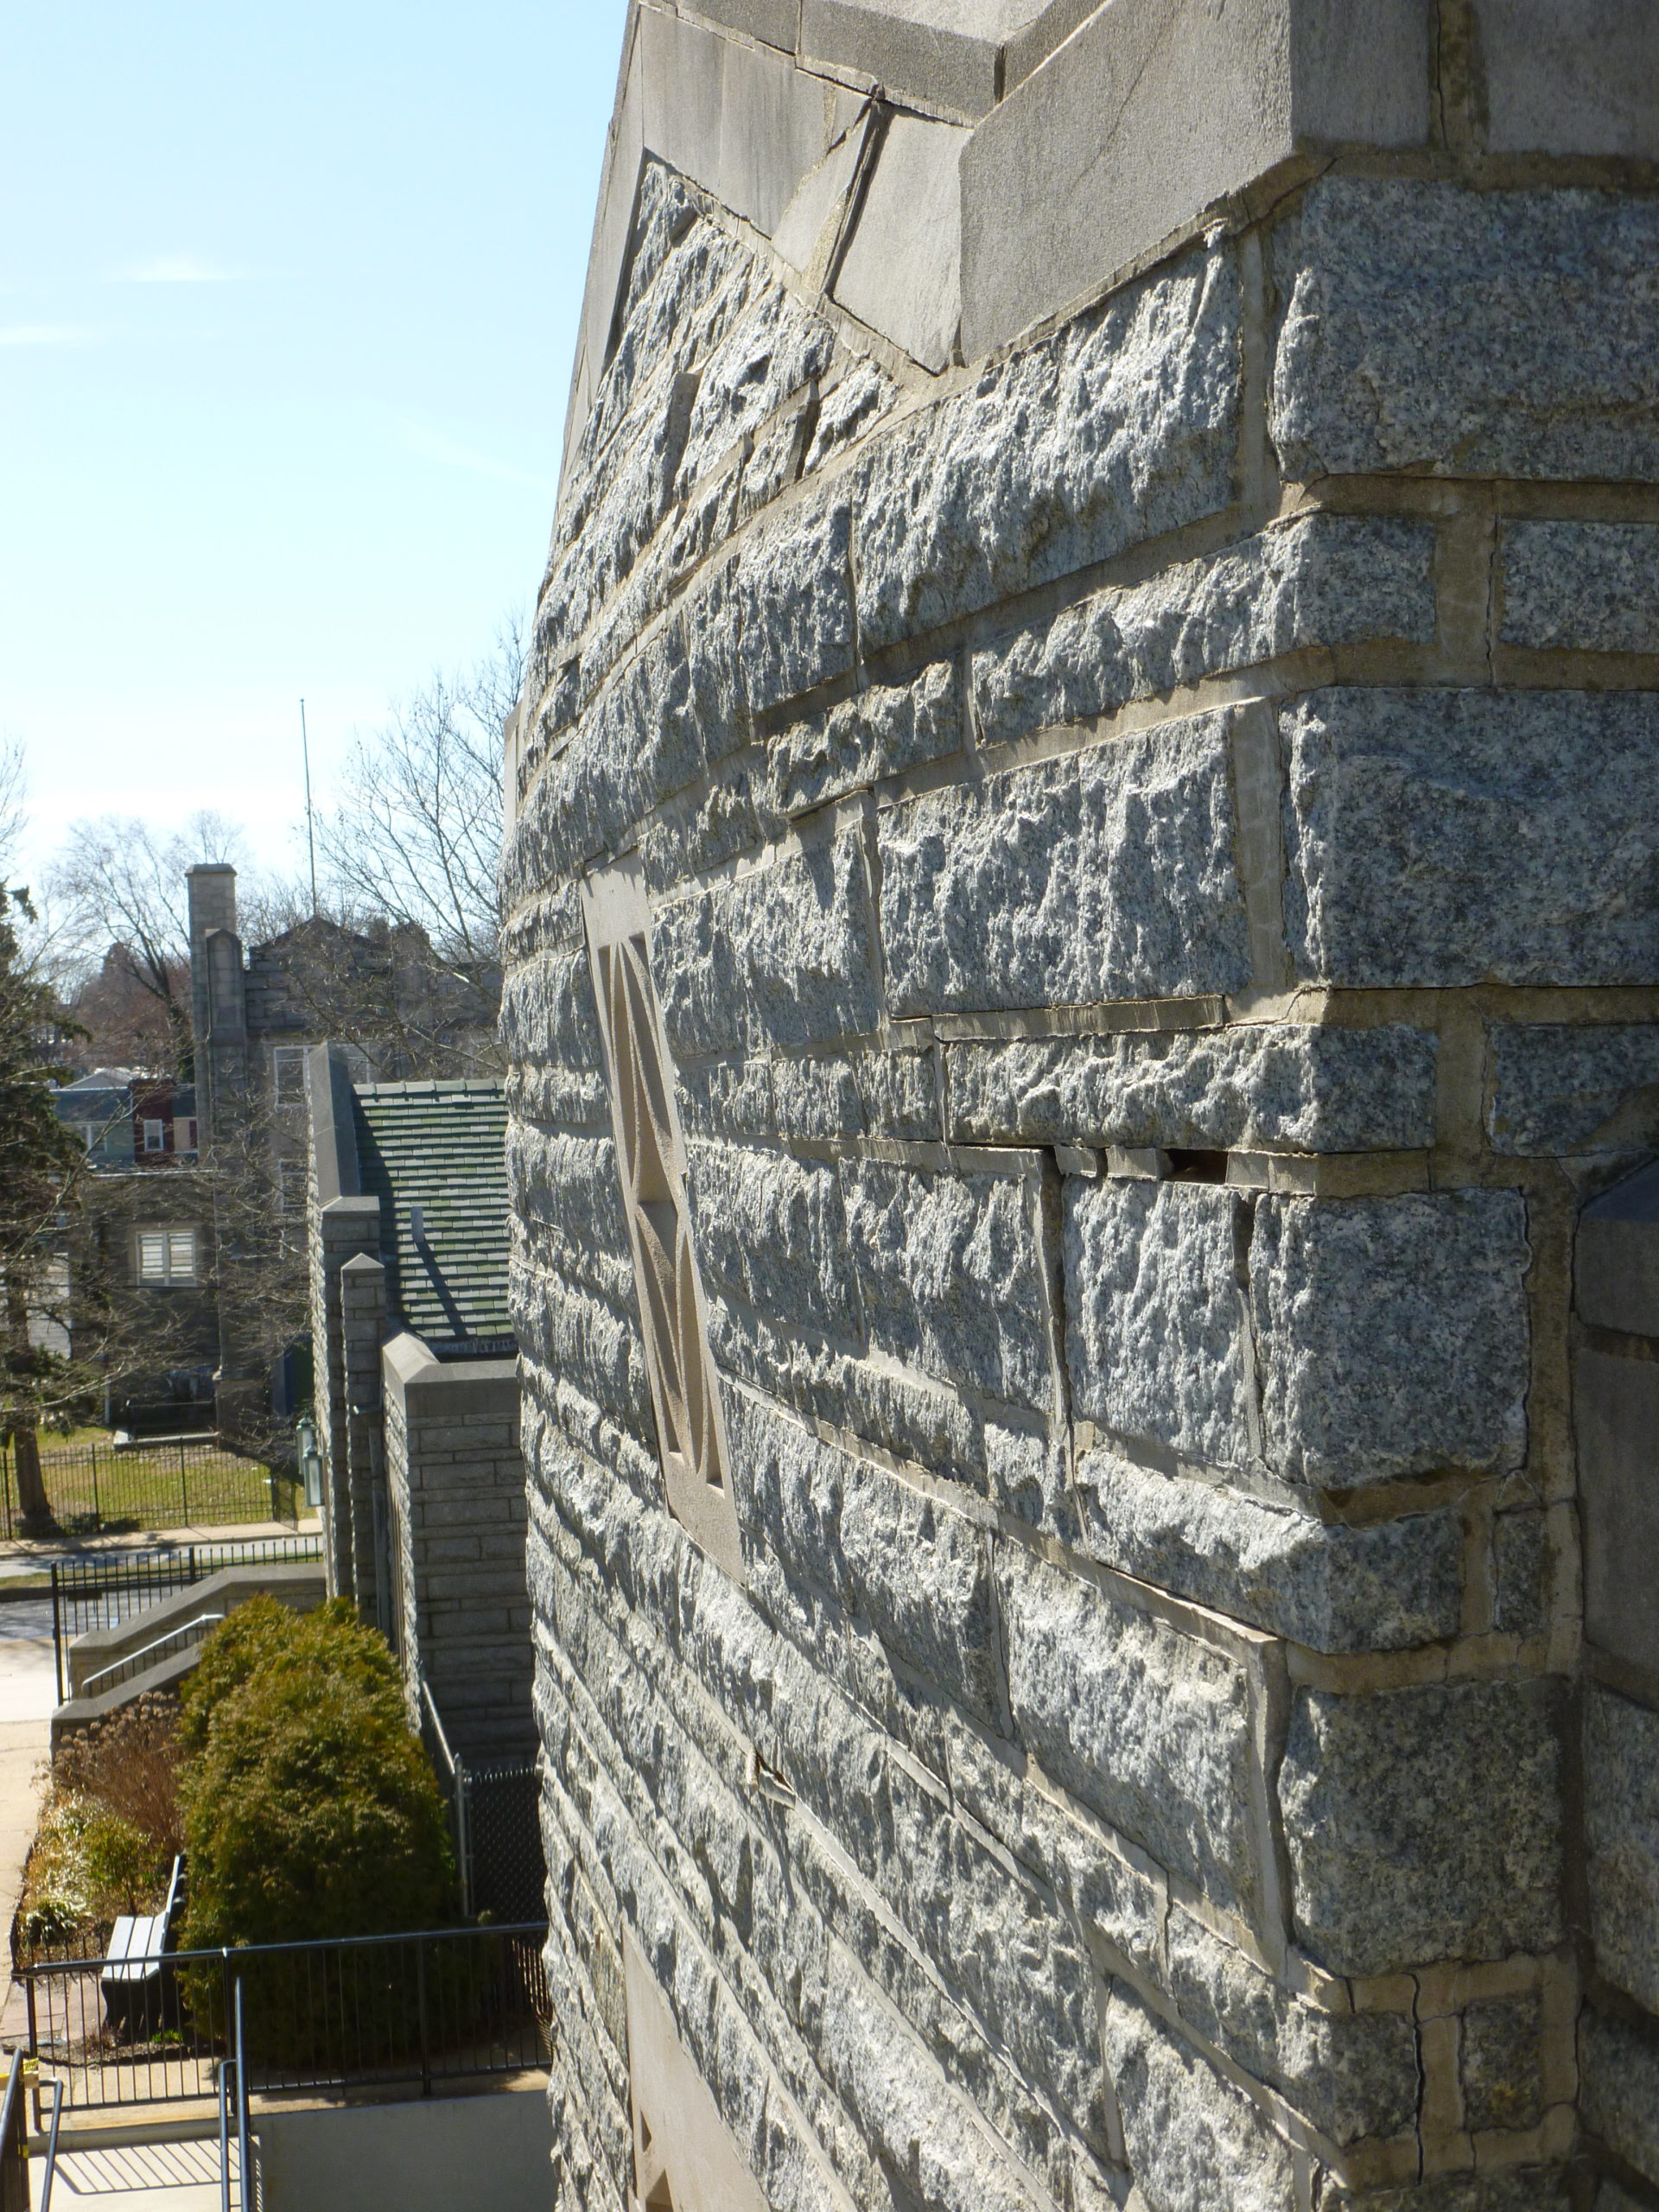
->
[0, 0, 624, 880]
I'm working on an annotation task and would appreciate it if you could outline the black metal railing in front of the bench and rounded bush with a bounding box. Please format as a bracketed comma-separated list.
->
[17, 1920, 553, 2110]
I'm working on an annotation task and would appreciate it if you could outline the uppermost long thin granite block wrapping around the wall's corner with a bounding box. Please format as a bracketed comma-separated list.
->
[973, 515, 1435, 743]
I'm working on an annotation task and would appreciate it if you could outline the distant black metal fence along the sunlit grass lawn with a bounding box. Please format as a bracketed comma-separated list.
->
[0, 1438, 299, 1540]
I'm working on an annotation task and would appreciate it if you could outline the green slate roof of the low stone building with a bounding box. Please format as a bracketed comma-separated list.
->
[352, 1084, 511, 1350]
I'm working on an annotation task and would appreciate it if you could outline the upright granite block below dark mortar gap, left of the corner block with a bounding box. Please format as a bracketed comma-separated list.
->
[1064, 1177, 1252, 1466]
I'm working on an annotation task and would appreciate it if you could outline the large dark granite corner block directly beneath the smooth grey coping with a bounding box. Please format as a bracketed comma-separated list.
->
[1272, 177, 1659, 482]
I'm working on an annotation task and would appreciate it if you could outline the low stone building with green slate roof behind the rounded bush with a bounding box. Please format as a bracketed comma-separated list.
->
[305, 1044, 536, 1765]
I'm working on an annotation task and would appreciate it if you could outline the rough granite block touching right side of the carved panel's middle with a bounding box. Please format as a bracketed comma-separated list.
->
[686, 1141, 858, 1338]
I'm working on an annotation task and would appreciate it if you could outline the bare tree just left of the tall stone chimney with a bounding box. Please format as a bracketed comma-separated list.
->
[47, 810, 245, 1073]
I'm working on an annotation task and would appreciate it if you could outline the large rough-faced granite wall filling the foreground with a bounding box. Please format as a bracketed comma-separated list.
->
[502, 0, 1659, 2212]
